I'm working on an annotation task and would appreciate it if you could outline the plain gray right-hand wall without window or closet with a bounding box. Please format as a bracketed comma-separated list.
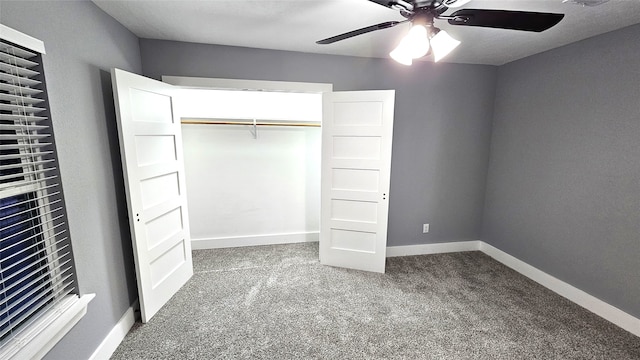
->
[483, 25, 640, 317]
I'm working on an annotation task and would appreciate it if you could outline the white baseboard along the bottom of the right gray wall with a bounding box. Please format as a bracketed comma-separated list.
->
[480, 241, 640, 337]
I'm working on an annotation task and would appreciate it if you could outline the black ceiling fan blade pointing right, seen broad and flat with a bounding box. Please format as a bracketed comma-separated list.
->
[445, 9, 564, 32]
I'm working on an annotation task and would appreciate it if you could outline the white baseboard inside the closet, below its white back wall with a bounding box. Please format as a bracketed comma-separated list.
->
[191, 231, 320, 250]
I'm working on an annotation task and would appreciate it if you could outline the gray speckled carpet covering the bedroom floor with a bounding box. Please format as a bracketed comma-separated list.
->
[112, 243, 640, 360]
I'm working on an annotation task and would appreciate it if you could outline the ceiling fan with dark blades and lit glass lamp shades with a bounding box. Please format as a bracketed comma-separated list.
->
[316, 0, 564, 65]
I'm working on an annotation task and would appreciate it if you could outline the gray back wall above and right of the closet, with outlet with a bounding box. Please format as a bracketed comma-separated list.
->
[140, 39, 496, 245]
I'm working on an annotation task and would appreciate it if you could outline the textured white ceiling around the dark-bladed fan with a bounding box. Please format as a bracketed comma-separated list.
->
[93, 0, 640, 65]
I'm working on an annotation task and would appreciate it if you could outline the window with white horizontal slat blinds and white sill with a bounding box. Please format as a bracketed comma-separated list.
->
[0, 25, 92, 359]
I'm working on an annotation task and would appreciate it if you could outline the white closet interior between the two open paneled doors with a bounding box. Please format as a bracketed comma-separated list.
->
[179, 89, 322, 249]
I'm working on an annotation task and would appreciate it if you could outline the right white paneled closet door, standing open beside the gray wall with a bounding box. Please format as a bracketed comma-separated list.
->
[320, 90, 395, 273]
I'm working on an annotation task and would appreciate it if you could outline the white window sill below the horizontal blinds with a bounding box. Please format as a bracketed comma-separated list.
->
[0, 294, 96, 359]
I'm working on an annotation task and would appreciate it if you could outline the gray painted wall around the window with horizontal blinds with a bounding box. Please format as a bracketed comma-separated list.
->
[0, 1, 141, 359]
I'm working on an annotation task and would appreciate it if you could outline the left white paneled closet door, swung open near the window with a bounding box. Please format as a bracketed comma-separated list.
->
[111, 69, 193, 322]
